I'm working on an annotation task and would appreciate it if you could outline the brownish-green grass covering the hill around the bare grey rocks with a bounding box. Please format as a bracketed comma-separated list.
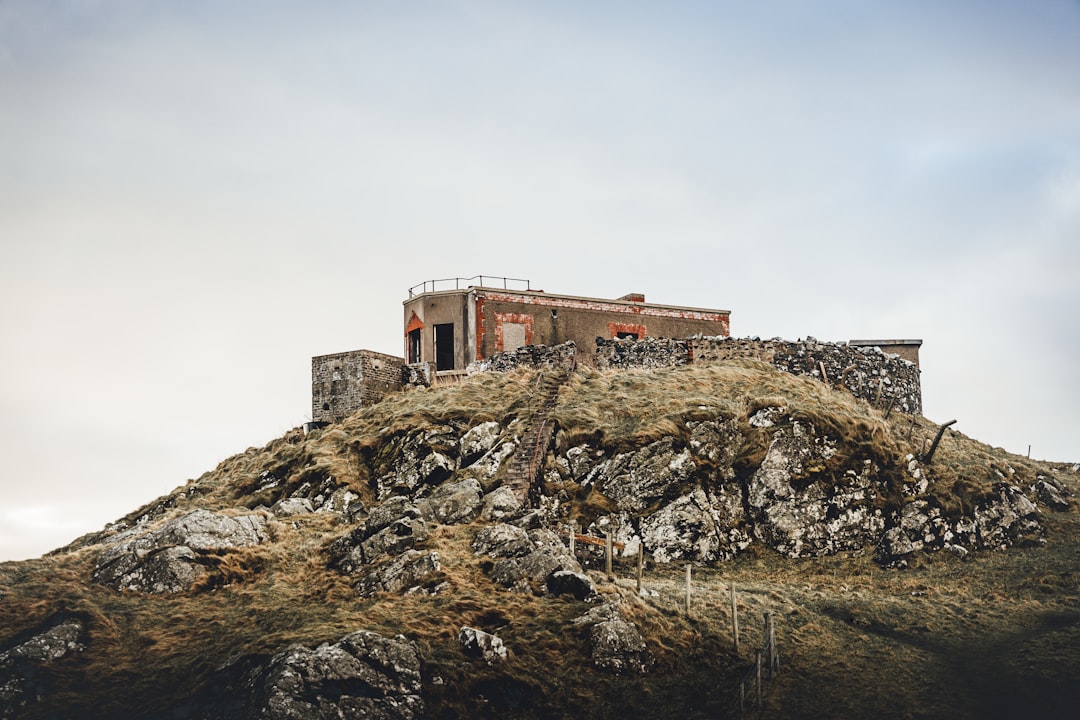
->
[0, 362, 1080, 719]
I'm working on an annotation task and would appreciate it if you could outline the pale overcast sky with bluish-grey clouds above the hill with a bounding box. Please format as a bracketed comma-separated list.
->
[0, 0, 1080, 560]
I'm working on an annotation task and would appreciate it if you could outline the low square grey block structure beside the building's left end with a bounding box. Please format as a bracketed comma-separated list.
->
[311, 350, 405, 422]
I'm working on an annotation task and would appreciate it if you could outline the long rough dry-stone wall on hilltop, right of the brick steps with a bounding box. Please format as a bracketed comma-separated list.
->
[596, 337, 922, 413]
